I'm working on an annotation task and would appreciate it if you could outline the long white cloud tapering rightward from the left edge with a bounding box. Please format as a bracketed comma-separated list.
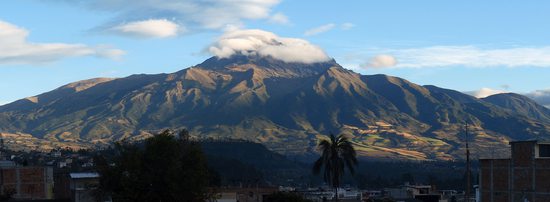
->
[0, 20, 124, 65]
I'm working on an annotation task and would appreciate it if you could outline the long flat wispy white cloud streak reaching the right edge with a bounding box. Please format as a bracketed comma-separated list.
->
[376, 46, 550, 68]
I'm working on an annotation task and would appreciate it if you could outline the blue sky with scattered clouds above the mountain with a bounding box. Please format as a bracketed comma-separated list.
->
[0, 0, 550, 104]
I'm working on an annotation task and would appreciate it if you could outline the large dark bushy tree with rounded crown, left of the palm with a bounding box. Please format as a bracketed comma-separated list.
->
[96, 130, 212, 201]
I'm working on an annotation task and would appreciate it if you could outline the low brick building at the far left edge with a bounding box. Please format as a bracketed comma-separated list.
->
[0, 161, 54, 200]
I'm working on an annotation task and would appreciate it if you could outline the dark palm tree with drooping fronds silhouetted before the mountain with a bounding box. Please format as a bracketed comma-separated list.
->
[313, 133, 357, 201]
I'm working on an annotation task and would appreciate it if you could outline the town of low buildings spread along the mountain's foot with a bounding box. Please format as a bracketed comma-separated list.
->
[0, 132, 550, 202]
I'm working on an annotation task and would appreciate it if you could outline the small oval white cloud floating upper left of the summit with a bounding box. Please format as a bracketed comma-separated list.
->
[112, 19, 185, 38]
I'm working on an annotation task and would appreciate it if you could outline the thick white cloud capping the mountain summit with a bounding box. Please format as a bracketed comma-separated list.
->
[208, 29, 331, 63]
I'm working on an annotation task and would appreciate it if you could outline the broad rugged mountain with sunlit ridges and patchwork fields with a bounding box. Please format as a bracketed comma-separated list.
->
[0, 56, 550, 159]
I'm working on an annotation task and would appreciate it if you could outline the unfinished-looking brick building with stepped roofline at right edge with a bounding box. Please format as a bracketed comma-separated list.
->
[479, 141, 550, 202]
